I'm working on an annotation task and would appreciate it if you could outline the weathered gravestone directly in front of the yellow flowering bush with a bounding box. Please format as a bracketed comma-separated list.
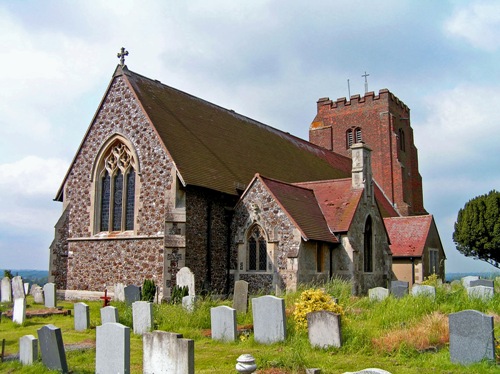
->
[307, 310, 342, 348]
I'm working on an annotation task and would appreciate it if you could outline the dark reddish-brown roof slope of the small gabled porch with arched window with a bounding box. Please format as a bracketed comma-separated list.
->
[256, 175, 338, 243]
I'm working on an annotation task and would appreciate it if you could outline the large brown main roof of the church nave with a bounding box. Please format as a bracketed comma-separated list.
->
[123, 68, 351, 194]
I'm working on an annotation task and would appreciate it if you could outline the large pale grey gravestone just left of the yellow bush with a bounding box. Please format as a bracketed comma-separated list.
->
[252, 295, 286, 344]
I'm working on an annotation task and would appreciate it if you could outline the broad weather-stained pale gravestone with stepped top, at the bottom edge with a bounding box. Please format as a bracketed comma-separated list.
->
[142, 331, 194, 374]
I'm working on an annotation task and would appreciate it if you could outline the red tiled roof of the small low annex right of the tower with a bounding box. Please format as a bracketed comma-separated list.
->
[384, 215, 433, 257]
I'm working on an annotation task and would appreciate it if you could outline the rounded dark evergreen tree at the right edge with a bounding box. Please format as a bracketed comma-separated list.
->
[453, 190, 500, 268]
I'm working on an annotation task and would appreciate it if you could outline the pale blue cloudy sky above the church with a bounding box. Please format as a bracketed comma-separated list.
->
[0, 0, 500, 272]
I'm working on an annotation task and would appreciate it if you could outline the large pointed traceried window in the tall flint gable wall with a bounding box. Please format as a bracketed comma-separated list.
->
[95, 140, 137, 232]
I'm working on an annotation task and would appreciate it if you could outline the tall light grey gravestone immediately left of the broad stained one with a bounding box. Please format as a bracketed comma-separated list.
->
[95, 322, 130, 374]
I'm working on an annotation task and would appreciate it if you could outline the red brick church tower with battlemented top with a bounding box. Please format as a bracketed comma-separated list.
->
[309, 89, 427, 216]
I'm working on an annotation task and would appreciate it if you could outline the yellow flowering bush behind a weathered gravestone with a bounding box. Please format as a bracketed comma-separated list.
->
[293, 289, 344, 330]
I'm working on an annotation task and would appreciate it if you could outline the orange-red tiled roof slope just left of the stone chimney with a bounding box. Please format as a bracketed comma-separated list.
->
[297, 178, 363, 233]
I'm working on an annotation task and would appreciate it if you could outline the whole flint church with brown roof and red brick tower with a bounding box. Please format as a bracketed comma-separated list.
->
[49, 65, 445, 298]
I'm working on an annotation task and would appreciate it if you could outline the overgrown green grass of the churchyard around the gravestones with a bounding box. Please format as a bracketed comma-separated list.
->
[0, 280, 500, 374]
